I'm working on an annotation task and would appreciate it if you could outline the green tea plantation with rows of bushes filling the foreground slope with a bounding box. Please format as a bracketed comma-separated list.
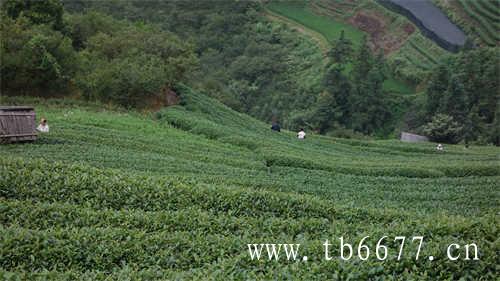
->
[0, 88, 500, 280]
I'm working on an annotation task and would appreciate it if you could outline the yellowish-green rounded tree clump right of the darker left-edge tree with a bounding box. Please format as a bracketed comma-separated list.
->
[70, 13, 196, 107]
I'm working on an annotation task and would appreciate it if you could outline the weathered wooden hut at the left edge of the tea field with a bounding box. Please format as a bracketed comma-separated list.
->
[0, 106, 37, 143]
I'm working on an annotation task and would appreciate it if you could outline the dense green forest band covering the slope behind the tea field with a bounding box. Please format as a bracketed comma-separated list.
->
[0, 0, 500, 145]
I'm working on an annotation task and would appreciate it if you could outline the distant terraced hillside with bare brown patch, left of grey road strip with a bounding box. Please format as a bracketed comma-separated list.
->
[266, 0, 451, 83]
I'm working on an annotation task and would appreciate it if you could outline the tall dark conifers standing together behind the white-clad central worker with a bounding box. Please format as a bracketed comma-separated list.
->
[308, 33, 401, 135]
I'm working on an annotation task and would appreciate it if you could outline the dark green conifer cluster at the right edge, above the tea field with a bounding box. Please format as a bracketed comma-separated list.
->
[420, 48, 500, 143]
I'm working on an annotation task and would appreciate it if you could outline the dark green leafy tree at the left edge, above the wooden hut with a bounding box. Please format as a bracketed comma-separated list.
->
[0, 15, 79, 96]
